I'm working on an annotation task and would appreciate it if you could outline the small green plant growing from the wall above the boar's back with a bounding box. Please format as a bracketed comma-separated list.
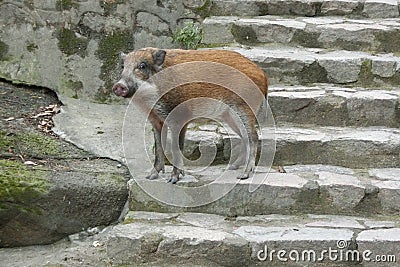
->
[172, 22, 203, 49]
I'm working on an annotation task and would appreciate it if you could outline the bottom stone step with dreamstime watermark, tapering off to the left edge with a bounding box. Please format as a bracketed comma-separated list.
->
[0, 211, 398, 267]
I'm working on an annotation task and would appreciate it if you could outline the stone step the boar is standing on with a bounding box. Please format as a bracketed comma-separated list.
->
[129, 165, 400, 217]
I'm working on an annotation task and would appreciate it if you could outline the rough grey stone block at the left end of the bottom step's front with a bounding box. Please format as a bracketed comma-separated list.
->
[107, 224, 248, 264]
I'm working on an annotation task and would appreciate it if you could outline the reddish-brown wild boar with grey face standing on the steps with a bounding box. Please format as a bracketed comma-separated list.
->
[112, 47, 268, 183]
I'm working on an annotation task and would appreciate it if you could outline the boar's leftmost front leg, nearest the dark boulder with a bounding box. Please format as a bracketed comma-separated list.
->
[146, 125, 168, 180]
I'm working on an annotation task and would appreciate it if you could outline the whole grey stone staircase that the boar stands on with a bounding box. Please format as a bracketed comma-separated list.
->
[107, 0, 400, 266]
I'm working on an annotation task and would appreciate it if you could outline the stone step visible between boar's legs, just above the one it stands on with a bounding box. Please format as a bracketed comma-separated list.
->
[178, 125, 400, 168]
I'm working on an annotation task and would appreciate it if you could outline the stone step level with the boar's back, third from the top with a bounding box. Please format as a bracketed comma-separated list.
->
[205, 45, 400, 87]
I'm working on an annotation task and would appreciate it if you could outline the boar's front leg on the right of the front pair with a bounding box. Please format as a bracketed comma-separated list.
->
[168, 124, 187, 184]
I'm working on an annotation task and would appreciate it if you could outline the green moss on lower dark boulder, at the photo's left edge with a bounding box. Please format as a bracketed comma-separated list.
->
[0, 160, 49, 215]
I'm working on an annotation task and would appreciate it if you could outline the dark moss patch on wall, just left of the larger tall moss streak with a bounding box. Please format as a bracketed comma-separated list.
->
[57, 28, 89, 57]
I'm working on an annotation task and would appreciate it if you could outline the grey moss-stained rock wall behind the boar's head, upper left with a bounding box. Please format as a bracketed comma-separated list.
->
[0, 0, 211, 102]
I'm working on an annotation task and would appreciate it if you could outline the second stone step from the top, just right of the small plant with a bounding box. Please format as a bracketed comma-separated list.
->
[203, 16, 400, 53]
